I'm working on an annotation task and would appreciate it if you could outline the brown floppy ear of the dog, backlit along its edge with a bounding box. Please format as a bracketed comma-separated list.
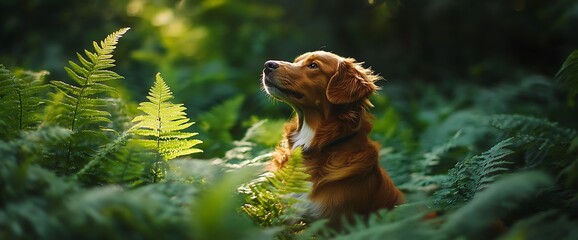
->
[325, 58, 379, 104]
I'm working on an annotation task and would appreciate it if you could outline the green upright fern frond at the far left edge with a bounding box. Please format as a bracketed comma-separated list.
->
[0, 64, 48, 140]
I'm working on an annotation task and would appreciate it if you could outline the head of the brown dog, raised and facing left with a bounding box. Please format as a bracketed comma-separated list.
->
[262, 51, 380, 108]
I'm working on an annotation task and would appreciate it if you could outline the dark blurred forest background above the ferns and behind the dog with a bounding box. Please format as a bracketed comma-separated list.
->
[0, 0, 578, 158]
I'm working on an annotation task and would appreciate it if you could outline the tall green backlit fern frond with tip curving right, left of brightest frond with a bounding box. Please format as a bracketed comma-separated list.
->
[46, 28, 129, 174]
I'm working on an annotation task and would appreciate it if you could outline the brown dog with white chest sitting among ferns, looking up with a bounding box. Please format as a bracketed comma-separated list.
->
[262, 51, 403, 226]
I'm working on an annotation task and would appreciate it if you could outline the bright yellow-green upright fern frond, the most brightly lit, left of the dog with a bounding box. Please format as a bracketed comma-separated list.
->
[131, 73, 202, 161]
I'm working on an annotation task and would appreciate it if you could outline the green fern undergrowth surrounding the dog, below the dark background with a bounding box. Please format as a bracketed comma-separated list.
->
[0, 28, 578, 239]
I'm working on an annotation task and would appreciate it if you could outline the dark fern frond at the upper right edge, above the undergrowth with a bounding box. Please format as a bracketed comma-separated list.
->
[556, 50, 578, 106]
